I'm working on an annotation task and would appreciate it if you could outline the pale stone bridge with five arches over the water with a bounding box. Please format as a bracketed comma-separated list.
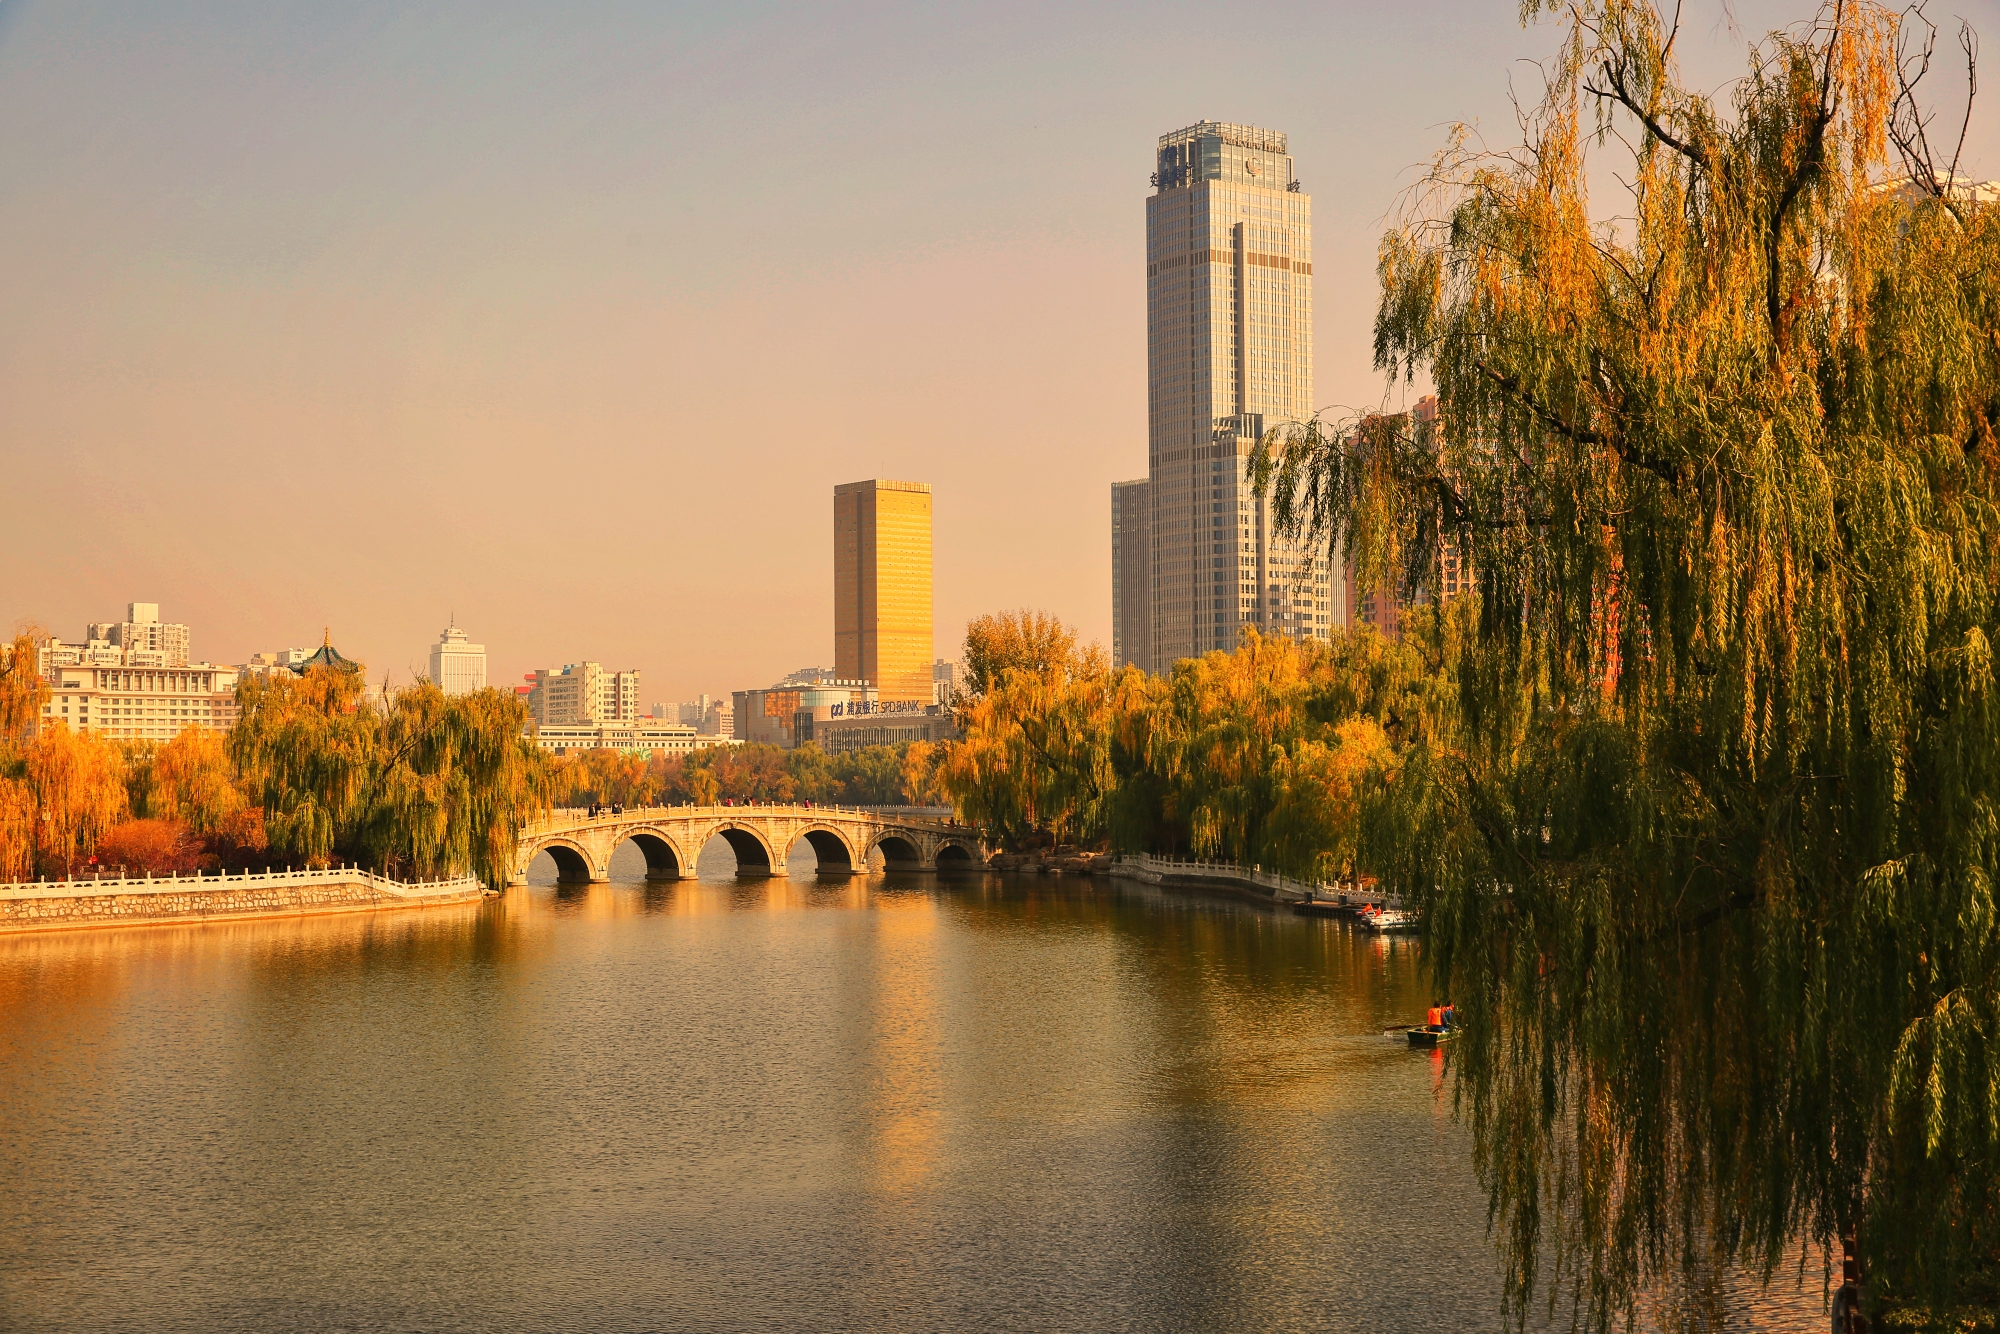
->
[514, 806, 986, 884]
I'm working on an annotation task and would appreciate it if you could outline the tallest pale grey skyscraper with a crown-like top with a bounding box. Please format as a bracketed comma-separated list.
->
[1152, 120, 1344, 672]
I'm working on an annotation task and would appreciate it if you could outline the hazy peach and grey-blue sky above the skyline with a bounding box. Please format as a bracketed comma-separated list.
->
[0, 0, 2000, 702]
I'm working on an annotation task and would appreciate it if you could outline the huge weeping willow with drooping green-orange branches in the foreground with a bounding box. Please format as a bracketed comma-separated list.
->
[1258, 0, 2000, 1328]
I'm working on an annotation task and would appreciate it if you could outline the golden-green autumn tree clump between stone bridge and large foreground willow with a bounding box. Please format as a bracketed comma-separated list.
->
[936, 616, 1422, 880]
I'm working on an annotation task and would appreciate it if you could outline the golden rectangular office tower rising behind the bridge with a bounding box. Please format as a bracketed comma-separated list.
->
[834, 480, 934, 700]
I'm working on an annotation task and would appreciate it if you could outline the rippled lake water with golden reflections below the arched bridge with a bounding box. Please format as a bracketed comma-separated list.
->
[0, 844, 1824, 1332]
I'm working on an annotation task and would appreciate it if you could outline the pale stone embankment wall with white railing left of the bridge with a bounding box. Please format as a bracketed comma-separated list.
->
[0, 870, 488, 932]
